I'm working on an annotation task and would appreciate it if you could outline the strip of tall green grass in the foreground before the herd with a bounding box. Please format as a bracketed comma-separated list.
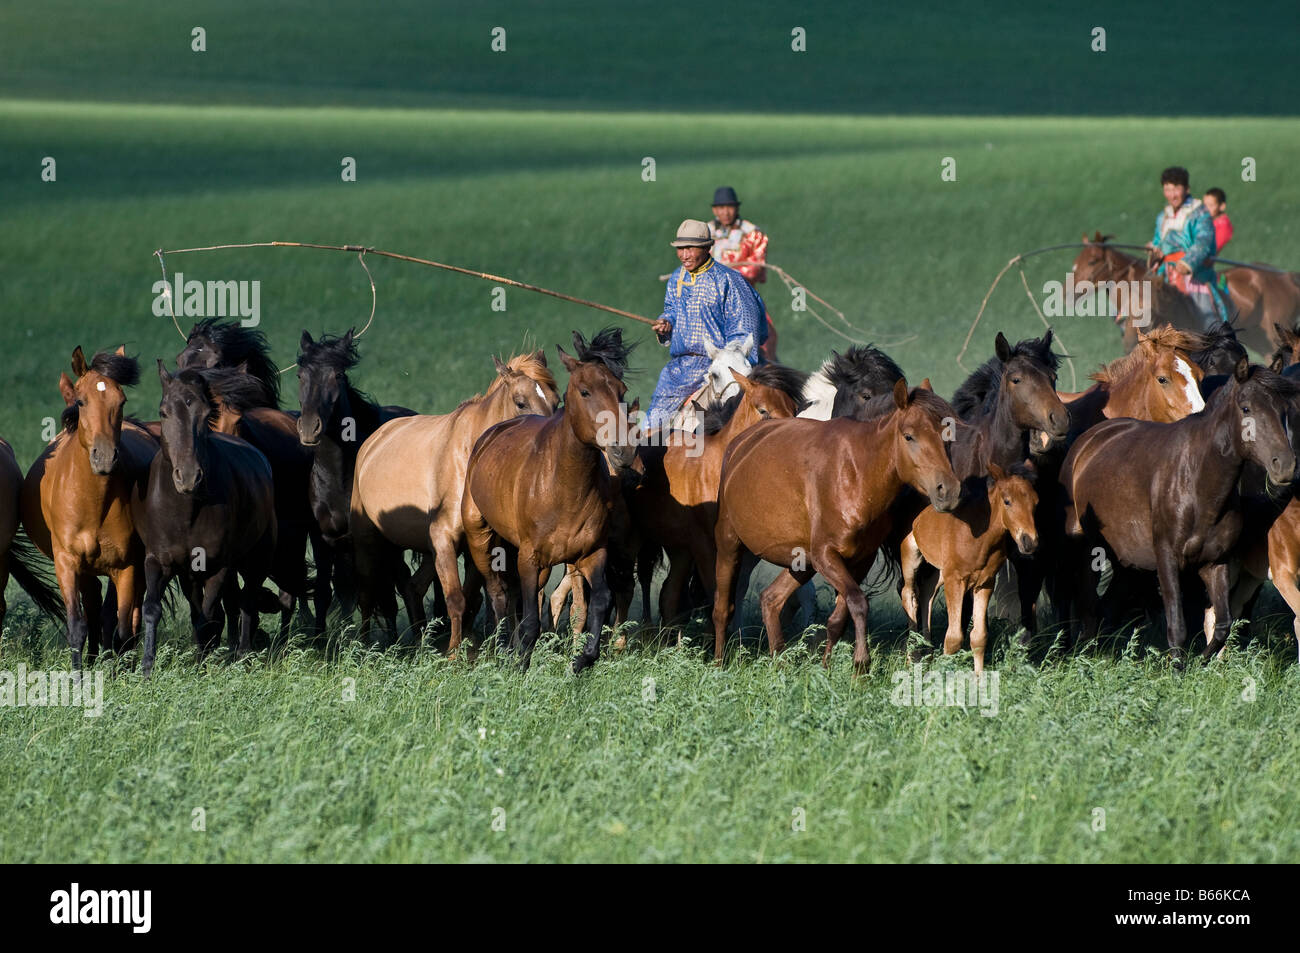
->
[0, 613, 1300, 863]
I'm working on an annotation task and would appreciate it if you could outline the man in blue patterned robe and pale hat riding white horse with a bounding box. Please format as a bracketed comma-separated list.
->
[646, 218, 767, 430]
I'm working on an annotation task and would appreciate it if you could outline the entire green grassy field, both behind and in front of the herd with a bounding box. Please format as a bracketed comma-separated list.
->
[0, 3, 1300, 862]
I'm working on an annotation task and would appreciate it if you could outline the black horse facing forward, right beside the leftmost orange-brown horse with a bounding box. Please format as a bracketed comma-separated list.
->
[131, 360, 276, 677]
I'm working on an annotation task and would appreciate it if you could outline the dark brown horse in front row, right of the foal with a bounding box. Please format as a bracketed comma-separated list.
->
[1060, 360, 1300, 660]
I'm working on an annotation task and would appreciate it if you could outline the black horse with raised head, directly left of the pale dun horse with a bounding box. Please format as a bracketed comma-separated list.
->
[298, 329, 415, 624]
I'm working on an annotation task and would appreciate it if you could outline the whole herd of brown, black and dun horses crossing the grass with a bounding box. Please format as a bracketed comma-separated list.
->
[0, 237, 1300, 675]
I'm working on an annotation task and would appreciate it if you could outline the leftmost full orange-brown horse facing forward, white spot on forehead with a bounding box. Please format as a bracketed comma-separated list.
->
[22, 347, 159, 668]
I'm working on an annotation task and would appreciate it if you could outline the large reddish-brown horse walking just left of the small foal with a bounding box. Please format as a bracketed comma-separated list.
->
[714, 380, 961, 671]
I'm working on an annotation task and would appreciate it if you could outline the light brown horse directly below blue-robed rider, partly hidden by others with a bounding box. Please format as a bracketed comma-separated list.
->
[633, 371, 797, 625]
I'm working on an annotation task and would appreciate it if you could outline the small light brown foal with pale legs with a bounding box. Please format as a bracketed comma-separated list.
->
[901, 463, 1039, 675]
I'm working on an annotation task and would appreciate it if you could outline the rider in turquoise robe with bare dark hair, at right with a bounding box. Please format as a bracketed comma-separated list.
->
[1147, 165, 1227, 330]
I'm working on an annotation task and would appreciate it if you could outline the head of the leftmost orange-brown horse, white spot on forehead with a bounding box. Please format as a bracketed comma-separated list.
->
[59, 346, 140, 476]
